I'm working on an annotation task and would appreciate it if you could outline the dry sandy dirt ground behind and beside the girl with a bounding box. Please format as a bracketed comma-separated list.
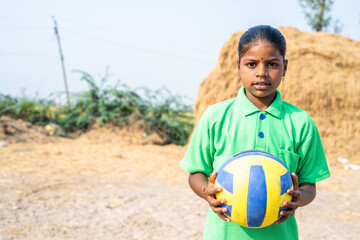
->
[0, 128, 360, 240]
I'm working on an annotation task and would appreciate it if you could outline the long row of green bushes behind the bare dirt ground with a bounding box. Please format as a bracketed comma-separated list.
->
[0, 70, 193, 145]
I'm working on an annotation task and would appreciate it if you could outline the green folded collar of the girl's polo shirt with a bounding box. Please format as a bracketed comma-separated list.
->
[237, 87, 282, 118]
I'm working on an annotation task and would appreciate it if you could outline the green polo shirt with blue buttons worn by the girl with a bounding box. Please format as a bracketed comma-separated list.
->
[181, 87, 330, 240]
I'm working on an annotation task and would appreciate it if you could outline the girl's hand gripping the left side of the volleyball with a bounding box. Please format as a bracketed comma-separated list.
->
[204, 172, 231, 222]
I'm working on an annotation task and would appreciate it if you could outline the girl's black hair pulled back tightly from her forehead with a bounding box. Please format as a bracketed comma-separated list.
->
[238, 25, 286, 61]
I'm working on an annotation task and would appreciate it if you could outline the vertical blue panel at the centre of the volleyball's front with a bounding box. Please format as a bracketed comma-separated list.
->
[246, 165, 267, 227]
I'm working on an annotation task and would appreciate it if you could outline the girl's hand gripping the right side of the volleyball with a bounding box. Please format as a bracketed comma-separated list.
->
[275, 173, 302, 224]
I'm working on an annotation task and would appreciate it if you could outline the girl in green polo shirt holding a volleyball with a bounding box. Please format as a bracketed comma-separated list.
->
[181, 25, 330, 240]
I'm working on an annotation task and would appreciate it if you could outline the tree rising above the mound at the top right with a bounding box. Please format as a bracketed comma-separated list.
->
[299, 0, 334, 32]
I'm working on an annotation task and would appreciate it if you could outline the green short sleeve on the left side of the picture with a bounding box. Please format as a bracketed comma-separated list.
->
[180, 109, 214, 176]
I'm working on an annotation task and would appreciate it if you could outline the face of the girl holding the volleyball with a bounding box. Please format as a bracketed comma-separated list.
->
[238, 41, 287, 103]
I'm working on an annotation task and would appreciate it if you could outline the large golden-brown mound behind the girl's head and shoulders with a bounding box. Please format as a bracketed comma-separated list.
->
[195, 27, 360, 163]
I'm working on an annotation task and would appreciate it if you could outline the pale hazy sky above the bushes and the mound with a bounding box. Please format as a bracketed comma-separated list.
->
[0, 0, 360, 102]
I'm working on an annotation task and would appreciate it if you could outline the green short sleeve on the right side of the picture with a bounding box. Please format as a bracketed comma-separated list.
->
[296, 116, 330, 183]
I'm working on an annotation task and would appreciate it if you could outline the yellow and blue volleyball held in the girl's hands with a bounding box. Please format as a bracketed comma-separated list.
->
[215, 150, 293, 228]
